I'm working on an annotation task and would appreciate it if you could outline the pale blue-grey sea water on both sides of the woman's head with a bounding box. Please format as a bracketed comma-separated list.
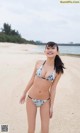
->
[35, 45, 80, 55]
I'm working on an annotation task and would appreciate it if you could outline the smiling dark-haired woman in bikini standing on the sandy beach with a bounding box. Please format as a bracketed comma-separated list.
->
[20, 42, 64, 133]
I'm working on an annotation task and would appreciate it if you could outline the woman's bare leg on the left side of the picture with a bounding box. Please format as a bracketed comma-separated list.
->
[26, 97, 37, 133]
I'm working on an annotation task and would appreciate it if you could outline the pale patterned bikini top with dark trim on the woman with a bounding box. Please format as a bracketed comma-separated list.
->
[36, 61, 56, 82]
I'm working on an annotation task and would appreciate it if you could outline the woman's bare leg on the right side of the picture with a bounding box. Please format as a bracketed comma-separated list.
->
[40, 100, 50, 133]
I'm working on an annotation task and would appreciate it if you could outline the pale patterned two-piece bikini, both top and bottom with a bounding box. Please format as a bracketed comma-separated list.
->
[28, 61, 56, 107]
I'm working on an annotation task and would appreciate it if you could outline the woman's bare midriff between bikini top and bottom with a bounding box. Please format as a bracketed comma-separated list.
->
[28, 77, 51, 99]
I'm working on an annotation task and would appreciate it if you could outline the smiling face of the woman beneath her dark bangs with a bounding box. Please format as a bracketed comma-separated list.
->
[44, 45, 58, 57]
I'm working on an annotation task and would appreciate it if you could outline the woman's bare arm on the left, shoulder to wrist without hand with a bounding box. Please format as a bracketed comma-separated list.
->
[23, 61, 39, 95]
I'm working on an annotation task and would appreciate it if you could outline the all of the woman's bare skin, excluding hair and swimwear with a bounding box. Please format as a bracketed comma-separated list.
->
[20, 46, 62, 133]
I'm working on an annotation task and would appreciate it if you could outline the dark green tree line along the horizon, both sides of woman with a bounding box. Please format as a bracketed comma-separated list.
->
[0, 23, 80, 46]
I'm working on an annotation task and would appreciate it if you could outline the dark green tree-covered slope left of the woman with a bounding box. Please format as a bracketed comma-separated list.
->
[0, 23, 35, 44]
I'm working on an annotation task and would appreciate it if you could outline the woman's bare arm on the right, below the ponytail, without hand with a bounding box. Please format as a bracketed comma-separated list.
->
[50, 73, 62, 109]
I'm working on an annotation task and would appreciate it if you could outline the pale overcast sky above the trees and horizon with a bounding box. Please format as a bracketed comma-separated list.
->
[0, 0, 80, 43]
